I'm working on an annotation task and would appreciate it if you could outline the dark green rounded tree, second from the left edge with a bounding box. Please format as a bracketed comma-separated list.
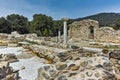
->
[7, 14, 28, 34]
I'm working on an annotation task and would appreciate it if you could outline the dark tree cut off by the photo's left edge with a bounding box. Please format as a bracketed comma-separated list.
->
[0, 17, 12, 33]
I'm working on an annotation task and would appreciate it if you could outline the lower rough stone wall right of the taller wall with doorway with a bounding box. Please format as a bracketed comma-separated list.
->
[96, 27, 120, 43]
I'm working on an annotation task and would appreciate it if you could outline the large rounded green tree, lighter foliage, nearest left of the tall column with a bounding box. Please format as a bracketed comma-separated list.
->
[29, 14, 53, 37]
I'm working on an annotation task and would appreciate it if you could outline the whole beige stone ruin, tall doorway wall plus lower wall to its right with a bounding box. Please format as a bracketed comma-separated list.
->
[68, 19, 120, 43]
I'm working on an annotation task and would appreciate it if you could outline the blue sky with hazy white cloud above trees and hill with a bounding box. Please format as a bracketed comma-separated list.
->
[0, 0, 120, 20]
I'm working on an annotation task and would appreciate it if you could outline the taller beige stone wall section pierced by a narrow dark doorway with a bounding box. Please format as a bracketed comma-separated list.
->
[68, 19, 99, 40]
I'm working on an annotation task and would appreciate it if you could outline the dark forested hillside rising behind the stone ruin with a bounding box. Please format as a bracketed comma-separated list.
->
[74, 13, 120, 27]
